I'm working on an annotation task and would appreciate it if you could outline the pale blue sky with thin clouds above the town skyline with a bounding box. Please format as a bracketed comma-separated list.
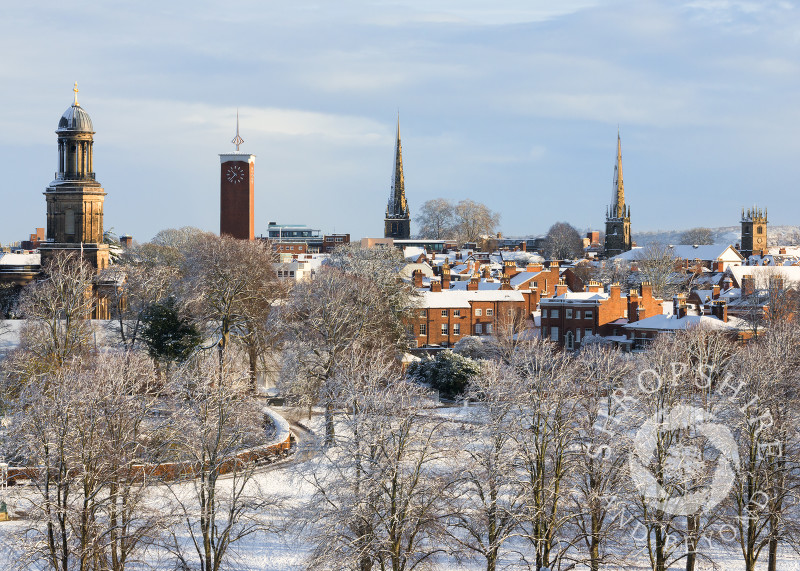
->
[0, 0, 800, 244]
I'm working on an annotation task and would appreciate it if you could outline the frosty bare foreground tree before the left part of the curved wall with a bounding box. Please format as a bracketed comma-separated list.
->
[165, 351, 274, 571]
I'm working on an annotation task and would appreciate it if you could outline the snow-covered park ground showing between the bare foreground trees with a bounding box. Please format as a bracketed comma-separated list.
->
[0, 407, 800, 571]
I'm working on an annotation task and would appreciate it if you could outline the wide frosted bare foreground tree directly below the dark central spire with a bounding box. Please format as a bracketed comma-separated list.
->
[303, 351, 452, 571]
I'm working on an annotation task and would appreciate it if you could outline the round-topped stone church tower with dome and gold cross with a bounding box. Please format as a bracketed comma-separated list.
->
[39, 83, 109, 270]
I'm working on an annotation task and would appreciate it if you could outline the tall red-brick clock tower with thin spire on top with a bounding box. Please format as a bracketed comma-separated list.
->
[219, 111, 256, 240]
